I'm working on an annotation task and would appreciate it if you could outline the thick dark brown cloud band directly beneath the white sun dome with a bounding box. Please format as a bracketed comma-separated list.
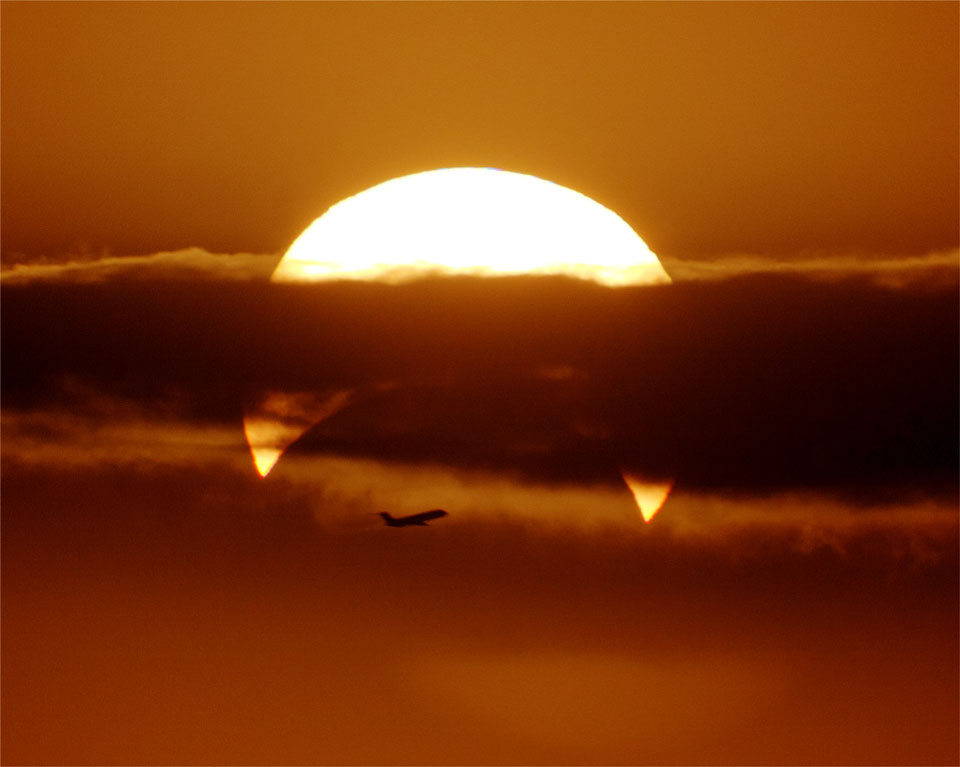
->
[2, 276, 958, 501]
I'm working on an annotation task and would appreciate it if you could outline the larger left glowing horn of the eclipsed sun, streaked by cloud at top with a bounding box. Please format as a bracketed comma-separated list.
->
[243, 390, 352, 477]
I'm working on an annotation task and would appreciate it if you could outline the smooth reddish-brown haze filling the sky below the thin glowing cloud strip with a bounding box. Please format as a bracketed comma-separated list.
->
[2, 456, 958, 764]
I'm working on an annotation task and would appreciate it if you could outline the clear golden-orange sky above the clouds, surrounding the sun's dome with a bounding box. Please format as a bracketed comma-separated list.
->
[2, 3, 960, 262]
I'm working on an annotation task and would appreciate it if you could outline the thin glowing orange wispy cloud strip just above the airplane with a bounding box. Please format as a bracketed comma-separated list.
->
[0, 390, 957, 548]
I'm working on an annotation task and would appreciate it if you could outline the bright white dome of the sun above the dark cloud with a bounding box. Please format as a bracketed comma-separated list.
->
[271, 168, 670, 287]
